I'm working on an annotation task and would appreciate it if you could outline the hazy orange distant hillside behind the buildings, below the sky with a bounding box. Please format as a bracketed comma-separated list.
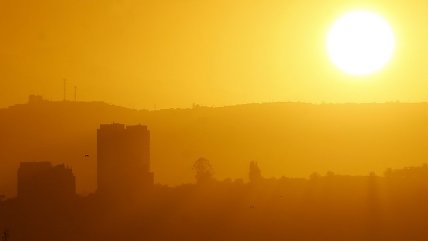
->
[0, 97, 428, 196]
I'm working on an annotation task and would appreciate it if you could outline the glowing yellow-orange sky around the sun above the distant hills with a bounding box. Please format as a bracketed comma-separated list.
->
[0, 0, 428, 108]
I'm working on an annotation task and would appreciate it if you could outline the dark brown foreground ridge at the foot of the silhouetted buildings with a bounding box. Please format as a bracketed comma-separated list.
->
[0, 160, 428, 241]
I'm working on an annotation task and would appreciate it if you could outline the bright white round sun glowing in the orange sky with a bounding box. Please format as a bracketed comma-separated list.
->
[327, 11, 395, 76]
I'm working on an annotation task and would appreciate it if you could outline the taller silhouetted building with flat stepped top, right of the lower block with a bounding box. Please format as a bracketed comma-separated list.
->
[97, 124, 153, 196]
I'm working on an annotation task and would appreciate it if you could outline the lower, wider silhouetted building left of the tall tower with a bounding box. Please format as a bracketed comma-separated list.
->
[18, 162, 76, 202]
